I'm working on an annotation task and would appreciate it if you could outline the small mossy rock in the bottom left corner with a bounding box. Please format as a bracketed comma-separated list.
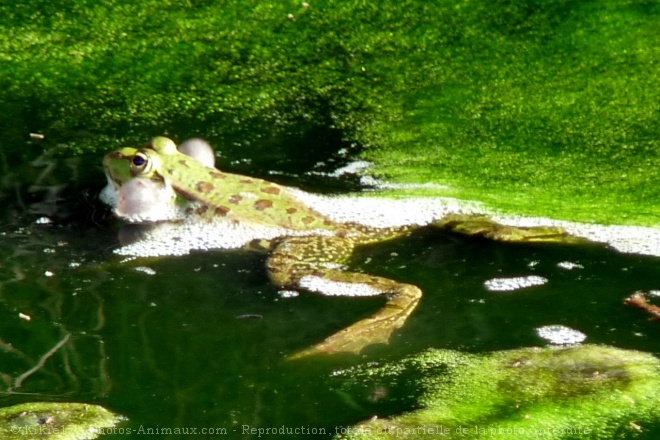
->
[0, 402, 124, 440]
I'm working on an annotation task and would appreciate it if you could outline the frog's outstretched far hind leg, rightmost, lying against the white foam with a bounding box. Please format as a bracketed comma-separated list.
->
[432, 214, 584, 243]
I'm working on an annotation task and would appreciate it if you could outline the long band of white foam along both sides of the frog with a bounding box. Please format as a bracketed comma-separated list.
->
[109, 188, 660, 260]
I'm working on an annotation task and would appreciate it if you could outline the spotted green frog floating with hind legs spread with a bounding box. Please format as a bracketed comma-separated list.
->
[103, 137, 573, 356]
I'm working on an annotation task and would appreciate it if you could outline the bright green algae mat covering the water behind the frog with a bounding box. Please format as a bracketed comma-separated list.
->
[0, 0, 660, 225]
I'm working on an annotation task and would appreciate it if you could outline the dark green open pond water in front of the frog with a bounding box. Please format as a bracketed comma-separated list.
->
[0, 152, 660, 438]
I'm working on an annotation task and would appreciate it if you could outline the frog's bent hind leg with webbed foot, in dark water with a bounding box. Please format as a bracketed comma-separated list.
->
[267, 236, 422, 358]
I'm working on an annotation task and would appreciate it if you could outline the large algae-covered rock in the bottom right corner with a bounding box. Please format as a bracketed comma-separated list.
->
[337, 345, 660, 439]
